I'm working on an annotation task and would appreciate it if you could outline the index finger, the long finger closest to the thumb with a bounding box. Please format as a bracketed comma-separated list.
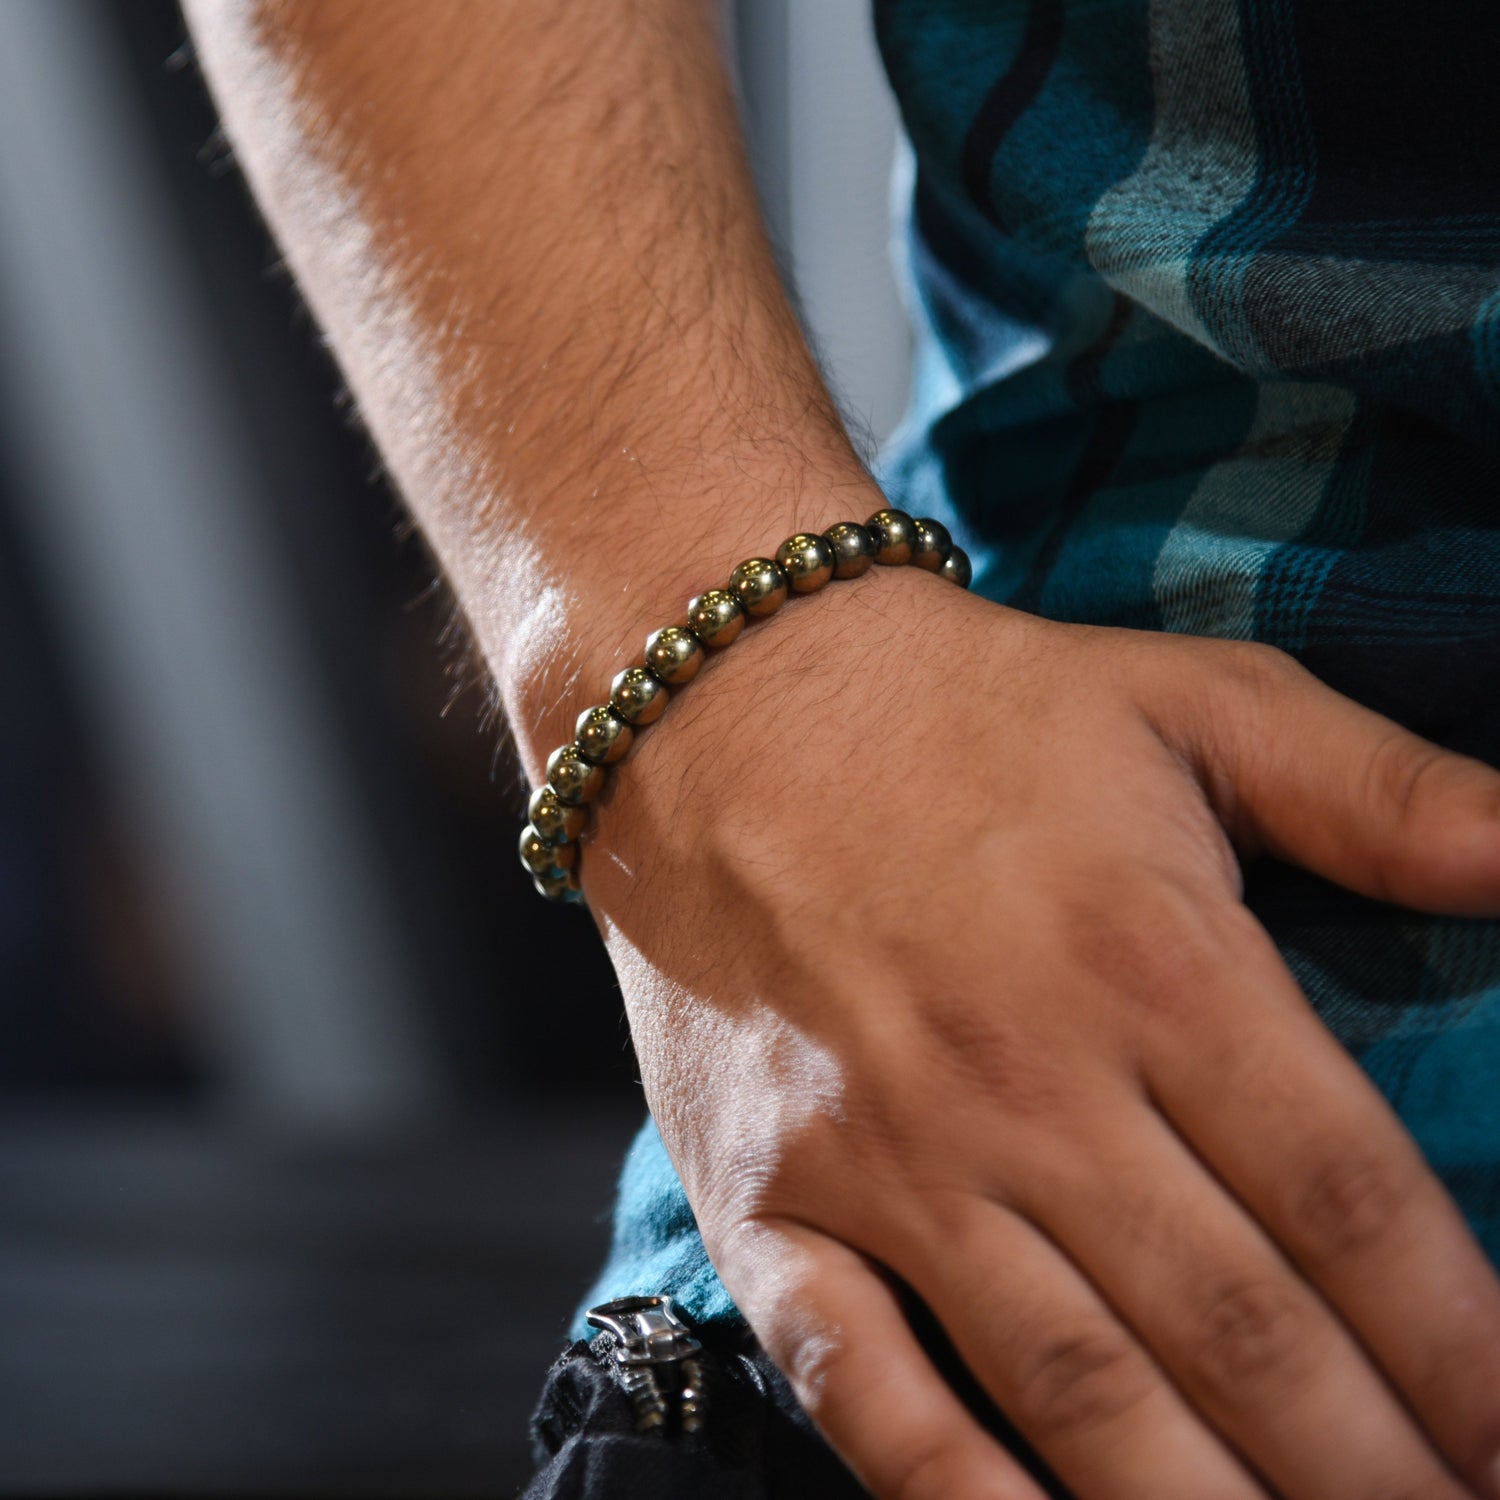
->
[1143, 917, 1500, 1497]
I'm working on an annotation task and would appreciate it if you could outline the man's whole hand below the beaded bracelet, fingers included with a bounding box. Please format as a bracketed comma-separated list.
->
[584, 572, 1500, 1500]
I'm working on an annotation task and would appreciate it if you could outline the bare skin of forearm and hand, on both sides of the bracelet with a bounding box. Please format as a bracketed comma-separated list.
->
[186, 0, 1500, 1500]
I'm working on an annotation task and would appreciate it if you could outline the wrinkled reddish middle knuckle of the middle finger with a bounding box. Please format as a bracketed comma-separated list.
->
[1190, 1280, 1323, 1398]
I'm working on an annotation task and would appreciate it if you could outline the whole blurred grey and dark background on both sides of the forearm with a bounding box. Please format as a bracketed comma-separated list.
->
[0, 0, 908, 1496]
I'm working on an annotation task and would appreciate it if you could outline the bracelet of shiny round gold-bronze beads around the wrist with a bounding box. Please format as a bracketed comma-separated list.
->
[519, 510, 972, 902]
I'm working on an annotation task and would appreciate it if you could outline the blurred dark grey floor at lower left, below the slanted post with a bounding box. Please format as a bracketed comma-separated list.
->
[0, 1110, 633, 1500]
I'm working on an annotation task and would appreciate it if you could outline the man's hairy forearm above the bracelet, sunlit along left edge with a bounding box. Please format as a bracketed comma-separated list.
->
[186, 0, 869, 777]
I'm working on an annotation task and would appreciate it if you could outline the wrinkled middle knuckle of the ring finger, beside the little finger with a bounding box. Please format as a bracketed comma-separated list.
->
[1016, 1325, 1155, 1439]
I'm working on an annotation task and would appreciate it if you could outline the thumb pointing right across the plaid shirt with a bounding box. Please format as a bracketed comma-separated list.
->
[1169, 647, 1500, 917]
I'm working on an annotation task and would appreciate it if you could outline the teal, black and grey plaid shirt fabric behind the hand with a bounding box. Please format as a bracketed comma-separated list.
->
[578, 0, 1500, 1337]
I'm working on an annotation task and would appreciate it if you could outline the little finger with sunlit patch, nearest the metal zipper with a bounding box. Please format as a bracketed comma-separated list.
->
[720, 1220, 1044, 1500]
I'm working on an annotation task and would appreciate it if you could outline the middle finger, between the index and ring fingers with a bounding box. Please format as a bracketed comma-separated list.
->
[1014, 1107, 1466, 1500]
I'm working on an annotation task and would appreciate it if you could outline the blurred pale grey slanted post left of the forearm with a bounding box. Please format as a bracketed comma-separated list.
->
[0, 0, 444, 1131]
